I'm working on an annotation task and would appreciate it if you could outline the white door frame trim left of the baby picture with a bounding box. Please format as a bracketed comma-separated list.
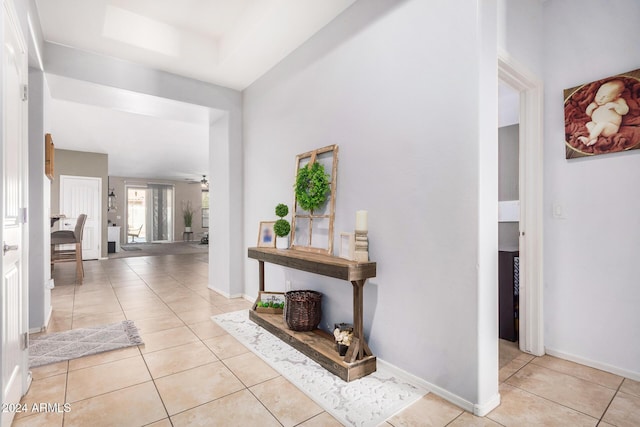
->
[498, 50, 545, 356]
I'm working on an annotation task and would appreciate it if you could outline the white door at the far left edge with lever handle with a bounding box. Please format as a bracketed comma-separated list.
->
[0, 0, 29, 426]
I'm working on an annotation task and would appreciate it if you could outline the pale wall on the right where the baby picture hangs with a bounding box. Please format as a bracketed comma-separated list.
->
[542, 0, 640, 380]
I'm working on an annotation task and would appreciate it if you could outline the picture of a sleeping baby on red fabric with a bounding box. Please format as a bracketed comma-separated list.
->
[564, 70, 640, 159]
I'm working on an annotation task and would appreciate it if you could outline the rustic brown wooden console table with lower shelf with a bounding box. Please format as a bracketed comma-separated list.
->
[248, 248, 376, 381]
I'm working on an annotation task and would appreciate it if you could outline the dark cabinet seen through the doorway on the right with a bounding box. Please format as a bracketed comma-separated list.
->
[498, 251, 520, 341]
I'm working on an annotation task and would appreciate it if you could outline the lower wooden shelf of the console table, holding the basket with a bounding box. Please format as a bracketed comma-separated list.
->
[249, 310, 376, 382]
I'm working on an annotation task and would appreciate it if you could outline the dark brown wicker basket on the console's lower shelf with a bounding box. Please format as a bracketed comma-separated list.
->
[284, 291, 322, 331]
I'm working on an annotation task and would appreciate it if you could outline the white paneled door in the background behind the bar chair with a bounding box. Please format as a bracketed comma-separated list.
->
[60, 175, 102, 259]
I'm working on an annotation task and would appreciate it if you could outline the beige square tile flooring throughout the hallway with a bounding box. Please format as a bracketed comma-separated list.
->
[13, 254, 640, 427]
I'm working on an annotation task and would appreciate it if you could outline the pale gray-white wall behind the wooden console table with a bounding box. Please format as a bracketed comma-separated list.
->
[244, 0, 497, 404]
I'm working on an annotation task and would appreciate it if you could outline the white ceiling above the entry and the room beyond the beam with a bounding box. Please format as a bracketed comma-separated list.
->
[36, 0, 356, 180]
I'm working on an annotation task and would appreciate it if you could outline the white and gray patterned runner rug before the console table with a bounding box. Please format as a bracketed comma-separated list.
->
[212, 310, 427, 426]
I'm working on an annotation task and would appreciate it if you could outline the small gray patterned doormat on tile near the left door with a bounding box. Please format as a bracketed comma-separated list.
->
[29, 320, 144, 368]
